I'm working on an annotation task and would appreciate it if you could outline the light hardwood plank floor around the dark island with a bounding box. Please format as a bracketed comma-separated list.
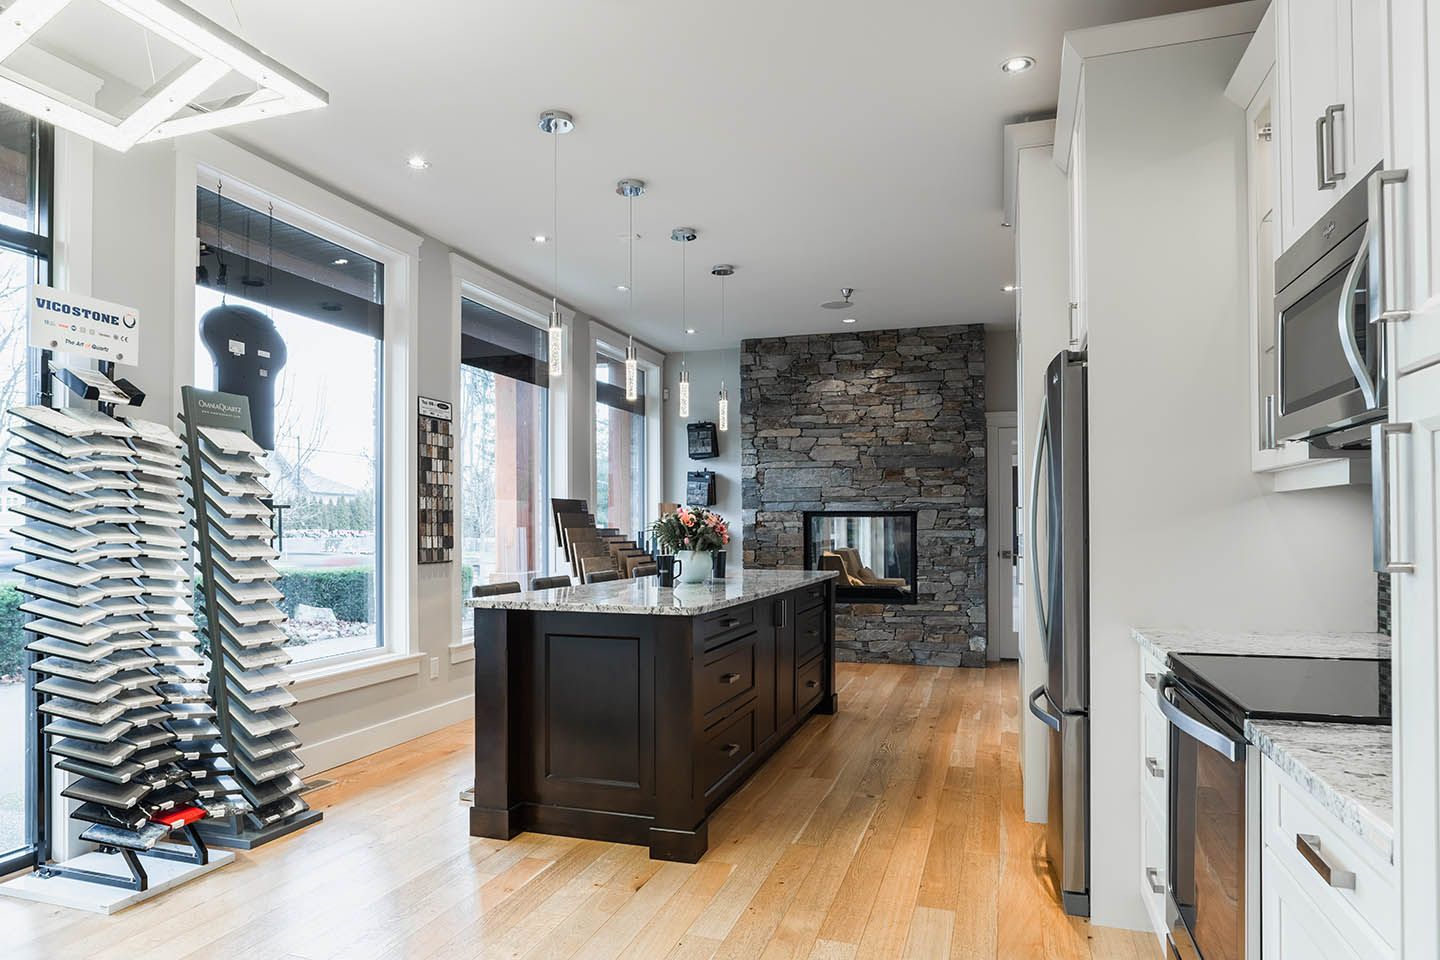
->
[0, 664, 1159, 960]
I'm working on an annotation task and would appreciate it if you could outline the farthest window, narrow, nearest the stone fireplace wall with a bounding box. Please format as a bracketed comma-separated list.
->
[595, 354, 649, 535]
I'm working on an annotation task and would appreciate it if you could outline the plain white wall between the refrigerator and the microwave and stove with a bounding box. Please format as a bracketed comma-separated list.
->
[1081, 36, 1375, 930]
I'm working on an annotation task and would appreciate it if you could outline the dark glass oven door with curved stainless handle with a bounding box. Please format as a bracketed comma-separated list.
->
[1158, 676, 1260, 960]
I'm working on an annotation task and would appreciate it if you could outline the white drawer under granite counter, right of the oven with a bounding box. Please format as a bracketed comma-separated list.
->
[1261, 759, 1400, 957]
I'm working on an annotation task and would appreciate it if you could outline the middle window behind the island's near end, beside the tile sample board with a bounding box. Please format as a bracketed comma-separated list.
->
[456, 299, 550, 635]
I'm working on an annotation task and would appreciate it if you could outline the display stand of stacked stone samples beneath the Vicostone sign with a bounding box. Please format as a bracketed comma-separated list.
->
[0, 350, 243, 910]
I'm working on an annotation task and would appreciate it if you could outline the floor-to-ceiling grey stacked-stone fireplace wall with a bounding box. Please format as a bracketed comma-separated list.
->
[739, 327, 988, 666]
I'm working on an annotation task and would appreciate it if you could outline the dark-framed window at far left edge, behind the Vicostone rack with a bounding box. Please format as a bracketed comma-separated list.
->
[0, 107, 53, 875]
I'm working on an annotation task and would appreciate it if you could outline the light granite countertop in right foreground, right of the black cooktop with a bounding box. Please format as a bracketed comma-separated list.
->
[1246, 720, 1395, 861]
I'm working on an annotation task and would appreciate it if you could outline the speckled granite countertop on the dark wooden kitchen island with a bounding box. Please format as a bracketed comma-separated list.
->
[465, 569, 837, 616]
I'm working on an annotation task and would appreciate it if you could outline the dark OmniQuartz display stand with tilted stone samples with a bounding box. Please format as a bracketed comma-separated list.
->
[180, 387, 321, 849]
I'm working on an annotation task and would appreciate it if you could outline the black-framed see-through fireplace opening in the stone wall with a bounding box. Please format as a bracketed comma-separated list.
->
[805, 510, 916, 603]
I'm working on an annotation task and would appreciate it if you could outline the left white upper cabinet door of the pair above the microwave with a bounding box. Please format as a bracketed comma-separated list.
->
[1276, 0, 1349, 248]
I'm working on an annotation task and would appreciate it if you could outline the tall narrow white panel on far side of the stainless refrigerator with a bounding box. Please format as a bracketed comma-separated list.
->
[1014, 136, 1070, 823]
